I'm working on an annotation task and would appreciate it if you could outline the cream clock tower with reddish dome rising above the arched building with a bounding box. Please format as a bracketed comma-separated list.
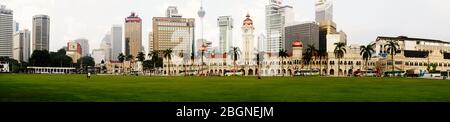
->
[242, 14, 255, 65]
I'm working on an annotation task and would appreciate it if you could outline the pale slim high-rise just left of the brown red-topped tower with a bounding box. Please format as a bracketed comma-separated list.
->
[110, 25, 123, 61]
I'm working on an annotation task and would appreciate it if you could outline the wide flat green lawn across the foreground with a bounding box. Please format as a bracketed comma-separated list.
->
[0, 74, 450, 102]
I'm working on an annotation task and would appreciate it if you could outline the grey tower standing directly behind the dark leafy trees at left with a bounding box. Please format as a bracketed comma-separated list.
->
[32, 15, 50, 50]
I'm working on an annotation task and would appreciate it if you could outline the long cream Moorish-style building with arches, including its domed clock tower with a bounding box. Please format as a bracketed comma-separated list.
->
[159, 15, 450, 76]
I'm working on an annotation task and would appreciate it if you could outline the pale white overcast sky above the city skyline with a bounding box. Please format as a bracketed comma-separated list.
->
[0, 0, 450, 51]
